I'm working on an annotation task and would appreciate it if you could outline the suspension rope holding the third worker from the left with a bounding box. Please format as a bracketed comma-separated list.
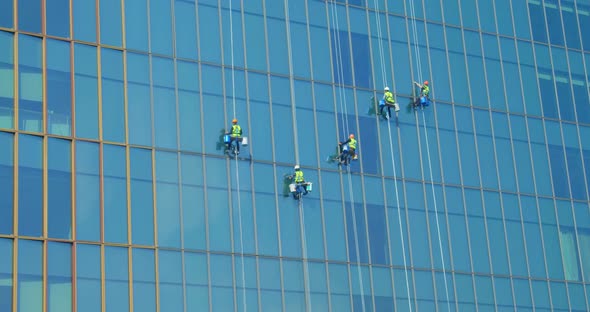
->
[330, 0, 365, 312]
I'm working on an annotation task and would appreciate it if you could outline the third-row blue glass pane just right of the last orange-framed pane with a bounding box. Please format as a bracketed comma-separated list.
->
[156, 152, 181, 248]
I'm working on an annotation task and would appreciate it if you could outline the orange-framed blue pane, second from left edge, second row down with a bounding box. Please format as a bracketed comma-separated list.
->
[18, 35, 43, 132]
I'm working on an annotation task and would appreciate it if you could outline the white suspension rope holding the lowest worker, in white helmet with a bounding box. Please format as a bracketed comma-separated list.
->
[286, 0, 312, 311]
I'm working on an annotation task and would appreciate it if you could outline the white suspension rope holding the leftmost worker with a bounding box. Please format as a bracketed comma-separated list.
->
[229, 0, 248, 312]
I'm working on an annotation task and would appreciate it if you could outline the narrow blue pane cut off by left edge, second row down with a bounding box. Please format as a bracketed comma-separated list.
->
[0, 31, 14, 128]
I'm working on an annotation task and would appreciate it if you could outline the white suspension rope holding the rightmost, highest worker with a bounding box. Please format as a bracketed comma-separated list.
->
[409, 0, 451, 311]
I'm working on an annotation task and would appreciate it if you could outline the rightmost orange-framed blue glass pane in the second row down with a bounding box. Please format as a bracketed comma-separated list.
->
[100, 48, 125, 143]
